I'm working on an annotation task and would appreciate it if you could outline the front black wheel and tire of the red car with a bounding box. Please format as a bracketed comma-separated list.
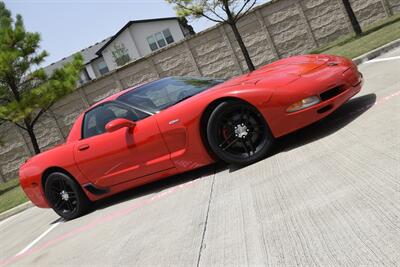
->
[207, 101, 274, 165]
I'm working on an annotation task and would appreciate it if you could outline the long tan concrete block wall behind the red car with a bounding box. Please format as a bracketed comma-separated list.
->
[0, 0, 400, 182]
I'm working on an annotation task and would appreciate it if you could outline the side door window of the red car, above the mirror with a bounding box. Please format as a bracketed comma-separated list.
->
[82, 104, 149, 138]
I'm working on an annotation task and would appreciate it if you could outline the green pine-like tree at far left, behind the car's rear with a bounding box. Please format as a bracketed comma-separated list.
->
[0, 2, 83, 154]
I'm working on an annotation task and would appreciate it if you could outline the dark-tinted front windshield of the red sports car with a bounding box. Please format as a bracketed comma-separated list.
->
[117, 77, 224, 113]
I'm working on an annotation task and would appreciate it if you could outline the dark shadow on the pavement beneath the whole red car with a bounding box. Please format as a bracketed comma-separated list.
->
[85, 94, 376, 216]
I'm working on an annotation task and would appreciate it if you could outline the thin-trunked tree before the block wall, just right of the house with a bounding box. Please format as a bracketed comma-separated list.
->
[166, 0, 257, 71]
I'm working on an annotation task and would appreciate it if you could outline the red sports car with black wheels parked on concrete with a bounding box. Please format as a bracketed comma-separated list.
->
[20, 55, 362, 219]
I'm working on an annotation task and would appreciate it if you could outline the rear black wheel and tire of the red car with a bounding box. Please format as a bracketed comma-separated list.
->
[44, 172, 91, 220]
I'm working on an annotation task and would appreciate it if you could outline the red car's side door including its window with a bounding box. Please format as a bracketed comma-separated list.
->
[74, 102, 174, 187]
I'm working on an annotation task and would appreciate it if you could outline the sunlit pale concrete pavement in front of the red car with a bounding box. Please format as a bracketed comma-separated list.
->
[0, 49, 400, 266]
